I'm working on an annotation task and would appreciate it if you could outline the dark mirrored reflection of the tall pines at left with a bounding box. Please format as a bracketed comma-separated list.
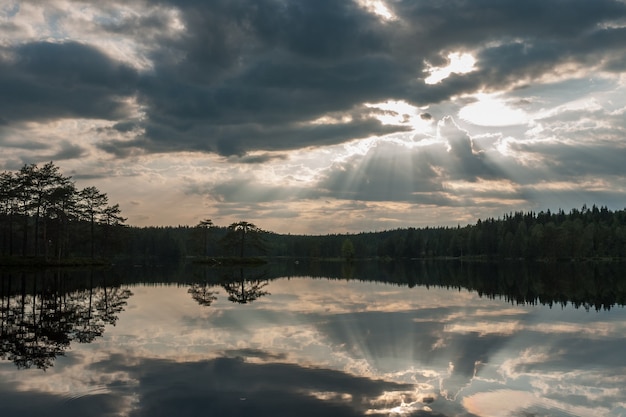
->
[0, 271, 132, 369]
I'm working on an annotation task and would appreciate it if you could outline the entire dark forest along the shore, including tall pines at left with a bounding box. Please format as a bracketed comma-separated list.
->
[0, 162, 626, 264]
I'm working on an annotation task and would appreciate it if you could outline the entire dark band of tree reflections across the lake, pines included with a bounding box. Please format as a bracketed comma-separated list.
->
[0, 261, 626, 369]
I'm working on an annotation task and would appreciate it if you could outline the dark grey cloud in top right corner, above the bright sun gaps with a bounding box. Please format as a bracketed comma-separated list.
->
[389, 0, 626, 59]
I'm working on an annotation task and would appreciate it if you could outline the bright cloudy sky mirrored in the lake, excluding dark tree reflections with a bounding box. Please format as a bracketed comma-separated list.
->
[0, 272, 626, 417]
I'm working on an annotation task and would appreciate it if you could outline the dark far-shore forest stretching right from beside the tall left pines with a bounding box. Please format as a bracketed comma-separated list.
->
[116, 206, 626, 261]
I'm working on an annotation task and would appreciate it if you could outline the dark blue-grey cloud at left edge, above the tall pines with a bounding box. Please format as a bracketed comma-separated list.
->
[0, 42, 137, 123]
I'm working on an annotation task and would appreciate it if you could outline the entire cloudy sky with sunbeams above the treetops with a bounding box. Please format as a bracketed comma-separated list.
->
[0, 0, 626, 234]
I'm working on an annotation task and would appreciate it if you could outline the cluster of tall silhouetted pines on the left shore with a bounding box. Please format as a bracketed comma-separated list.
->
[0, 162, 126, 261]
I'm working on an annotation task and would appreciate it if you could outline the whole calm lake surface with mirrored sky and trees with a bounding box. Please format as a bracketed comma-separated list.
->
[0, 261, 626, 417]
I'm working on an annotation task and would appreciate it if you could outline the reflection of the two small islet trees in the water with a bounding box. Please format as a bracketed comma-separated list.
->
[187, 268, 269, 306]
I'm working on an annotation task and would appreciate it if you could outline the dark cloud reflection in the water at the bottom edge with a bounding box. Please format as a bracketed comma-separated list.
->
[89, 357, 420, 417]
